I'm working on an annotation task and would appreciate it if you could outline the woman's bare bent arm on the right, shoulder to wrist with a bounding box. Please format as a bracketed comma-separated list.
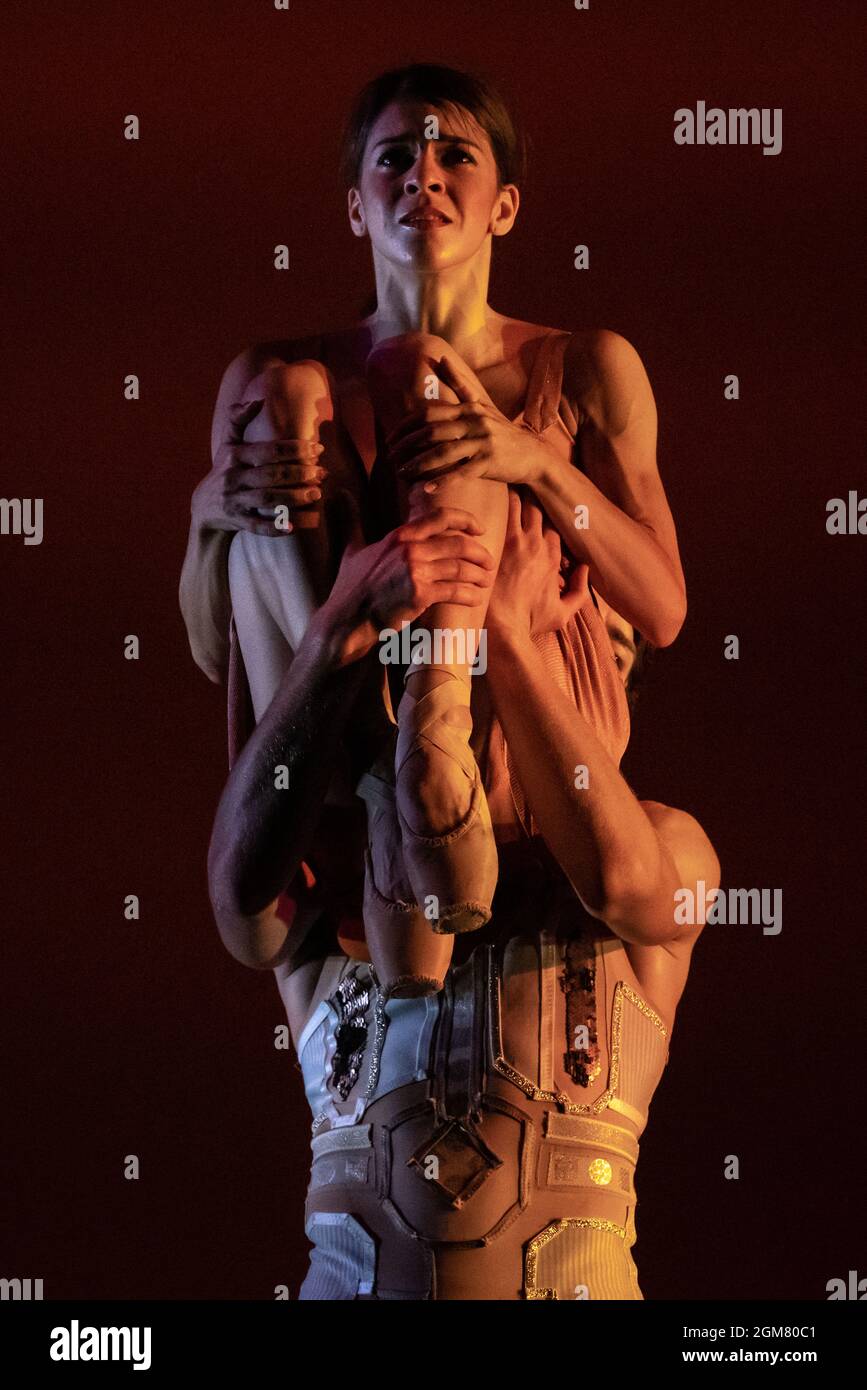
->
[534, 329, 686, 646]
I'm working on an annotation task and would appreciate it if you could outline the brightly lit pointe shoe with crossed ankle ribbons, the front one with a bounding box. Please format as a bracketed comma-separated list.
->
[395, 667, 499, 935]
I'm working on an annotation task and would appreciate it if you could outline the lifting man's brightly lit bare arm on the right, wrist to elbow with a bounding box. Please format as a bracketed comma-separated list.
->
[488, 628, 718, 945]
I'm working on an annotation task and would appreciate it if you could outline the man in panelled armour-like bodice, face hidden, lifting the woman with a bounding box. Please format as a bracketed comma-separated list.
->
[208, 492, 718, 1300]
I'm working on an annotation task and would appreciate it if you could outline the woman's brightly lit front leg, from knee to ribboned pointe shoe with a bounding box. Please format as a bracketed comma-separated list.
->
[367, 334, 509, 933]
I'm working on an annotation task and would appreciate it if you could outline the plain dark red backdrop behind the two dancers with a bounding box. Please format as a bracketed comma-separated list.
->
[0, 0, 867, 1298]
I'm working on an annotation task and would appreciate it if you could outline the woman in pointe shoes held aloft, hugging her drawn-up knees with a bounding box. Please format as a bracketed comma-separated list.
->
[182, 65, 685, 994]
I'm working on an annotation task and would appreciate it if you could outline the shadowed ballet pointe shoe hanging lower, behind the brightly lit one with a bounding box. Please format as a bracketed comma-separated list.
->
[356, 759, 454, 999]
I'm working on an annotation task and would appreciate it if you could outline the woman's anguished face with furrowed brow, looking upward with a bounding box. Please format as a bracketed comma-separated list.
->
[349, 101, 518, 274]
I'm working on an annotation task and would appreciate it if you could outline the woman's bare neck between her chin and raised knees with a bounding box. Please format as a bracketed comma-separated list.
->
[365, 246, 502, 370]
